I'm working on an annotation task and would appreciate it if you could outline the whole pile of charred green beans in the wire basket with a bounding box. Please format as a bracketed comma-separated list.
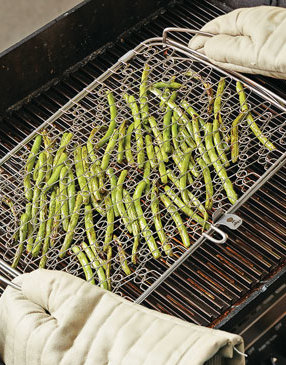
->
[9, 64, 275, 290]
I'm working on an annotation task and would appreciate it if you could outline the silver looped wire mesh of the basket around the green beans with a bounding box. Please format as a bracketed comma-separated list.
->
[0, 41, 286, 294]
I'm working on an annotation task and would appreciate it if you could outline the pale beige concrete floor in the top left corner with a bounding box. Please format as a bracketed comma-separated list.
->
[0, 0, 82, 52]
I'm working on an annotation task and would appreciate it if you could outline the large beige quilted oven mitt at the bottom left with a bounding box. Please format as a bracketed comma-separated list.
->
[0, 269, 244, 365]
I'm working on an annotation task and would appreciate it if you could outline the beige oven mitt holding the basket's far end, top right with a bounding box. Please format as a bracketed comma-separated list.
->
[189, 6, 286, 79]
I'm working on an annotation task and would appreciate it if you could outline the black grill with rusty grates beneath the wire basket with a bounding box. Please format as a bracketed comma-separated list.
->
[0, 1, 286, 362]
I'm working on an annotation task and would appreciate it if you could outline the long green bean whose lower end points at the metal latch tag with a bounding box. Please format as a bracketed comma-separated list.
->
[205, 123, 237, 204]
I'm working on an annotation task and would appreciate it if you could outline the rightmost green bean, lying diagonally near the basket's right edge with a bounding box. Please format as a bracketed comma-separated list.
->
[236, 81, 276, 151]
